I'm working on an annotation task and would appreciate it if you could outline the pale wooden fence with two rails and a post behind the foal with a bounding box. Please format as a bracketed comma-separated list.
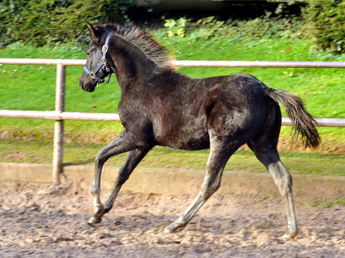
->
[0, 58, 345, 184]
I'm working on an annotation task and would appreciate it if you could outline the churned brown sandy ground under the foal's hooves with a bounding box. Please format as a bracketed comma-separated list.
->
[0, 181, 345, 258]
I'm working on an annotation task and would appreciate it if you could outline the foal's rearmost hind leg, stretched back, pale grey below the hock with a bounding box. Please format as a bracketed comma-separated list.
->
[248, 142, 298, 238]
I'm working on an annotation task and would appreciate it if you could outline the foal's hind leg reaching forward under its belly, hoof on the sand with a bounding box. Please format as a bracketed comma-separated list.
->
[164, 140, 239, 233]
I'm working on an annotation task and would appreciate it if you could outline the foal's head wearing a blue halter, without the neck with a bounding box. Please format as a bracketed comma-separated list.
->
[79, 23, 113, 92]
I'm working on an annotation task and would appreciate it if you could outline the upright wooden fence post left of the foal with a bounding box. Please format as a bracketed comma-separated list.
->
[53, 64, 66, 185]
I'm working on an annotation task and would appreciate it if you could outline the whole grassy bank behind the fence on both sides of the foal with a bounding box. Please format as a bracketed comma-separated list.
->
[0, 27, 345, 175]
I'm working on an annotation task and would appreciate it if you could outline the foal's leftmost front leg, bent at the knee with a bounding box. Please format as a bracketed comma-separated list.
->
[89, 130, 137, 223]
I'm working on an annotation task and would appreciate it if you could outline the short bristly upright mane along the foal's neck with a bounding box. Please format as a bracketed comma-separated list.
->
[96, 23, 175, 69]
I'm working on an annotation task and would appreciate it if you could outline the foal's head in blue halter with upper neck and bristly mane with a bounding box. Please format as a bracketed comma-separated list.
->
[79, 23, 175, 92]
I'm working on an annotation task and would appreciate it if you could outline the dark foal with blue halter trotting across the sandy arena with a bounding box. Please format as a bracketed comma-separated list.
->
[79, 24, 320, 237]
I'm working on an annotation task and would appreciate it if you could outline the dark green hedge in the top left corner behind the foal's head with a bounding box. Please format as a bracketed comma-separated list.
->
[0, 0, 136, 47]
